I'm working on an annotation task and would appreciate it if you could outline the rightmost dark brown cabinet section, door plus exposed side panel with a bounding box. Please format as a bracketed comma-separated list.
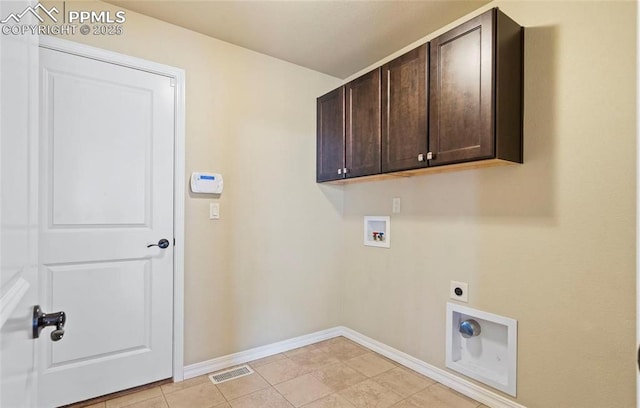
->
[429, 9, 523, 166]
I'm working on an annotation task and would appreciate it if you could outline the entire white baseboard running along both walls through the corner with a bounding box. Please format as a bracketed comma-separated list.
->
[184, 326, 526, 408]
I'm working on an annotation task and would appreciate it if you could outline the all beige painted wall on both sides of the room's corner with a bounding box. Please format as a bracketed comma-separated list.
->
[46, 1, 636, 408]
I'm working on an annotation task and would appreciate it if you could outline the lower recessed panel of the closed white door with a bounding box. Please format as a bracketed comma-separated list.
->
[47, 259, 151, 367]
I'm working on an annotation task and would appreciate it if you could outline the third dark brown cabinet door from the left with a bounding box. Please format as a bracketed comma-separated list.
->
[382, 44, 428, 172]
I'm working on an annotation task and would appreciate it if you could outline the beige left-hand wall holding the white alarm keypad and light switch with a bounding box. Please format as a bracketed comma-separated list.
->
[51, 2, 342, 364]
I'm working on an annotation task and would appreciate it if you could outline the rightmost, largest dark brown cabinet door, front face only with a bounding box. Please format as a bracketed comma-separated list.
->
[429, 10, 495, 166]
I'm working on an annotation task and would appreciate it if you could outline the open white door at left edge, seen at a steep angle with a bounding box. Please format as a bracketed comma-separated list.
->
[0, 1, 38, 408]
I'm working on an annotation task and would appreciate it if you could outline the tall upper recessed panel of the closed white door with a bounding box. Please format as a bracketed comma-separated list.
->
[48, 72, 153, 227]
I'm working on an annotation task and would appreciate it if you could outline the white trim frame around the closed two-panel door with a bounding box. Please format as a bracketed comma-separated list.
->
[40, 36, 185, 382]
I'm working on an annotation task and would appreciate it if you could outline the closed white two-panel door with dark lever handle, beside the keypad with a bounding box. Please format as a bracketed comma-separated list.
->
[39, 48, 175, 407]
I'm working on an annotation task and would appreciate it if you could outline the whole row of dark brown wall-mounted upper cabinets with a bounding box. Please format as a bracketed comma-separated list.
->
[317, 8, 524, 182]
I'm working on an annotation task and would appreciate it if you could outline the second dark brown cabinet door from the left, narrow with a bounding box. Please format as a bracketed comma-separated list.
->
[345, 68, 380, 177]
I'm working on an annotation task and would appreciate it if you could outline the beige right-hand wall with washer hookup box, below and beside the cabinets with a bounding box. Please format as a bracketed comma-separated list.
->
[343, 1, 636, 408]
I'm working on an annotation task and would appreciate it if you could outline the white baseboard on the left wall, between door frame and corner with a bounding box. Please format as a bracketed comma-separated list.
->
[184, 327, 342, 380]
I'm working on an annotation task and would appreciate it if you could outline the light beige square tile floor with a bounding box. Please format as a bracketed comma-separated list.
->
[75, 337, 487, 408]
